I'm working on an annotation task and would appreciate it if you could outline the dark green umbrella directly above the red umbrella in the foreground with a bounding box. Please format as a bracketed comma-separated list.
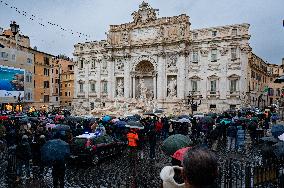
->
[162, 134, 192, 156]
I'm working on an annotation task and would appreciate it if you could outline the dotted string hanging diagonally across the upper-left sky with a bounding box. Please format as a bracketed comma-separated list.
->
[0, 0, 91, 41]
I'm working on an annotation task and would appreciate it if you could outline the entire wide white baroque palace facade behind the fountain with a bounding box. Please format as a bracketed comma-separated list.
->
[73, 2, 254, 113]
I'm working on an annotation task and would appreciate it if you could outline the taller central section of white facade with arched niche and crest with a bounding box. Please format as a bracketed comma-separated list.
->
[106, 2, 190, 108]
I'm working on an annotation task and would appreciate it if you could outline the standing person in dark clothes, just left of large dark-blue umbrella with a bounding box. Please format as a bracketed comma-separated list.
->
[16, 135, 32, 181]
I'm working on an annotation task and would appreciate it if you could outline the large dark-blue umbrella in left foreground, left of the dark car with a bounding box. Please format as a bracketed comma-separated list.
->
[41, 139, 70, 162]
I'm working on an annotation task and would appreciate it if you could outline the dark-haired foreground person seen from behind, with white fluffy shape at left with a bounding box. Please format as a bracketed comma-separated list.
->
[160, 147, 218, 188]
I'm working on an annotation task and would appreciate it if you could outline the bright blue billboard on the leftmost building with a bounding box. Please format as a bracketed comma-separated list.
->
[0, 65, 25, 102]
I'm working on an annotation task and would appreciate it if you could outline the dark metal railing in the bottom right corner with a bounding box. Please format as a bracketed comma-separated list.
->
[217, 157, 284, 188]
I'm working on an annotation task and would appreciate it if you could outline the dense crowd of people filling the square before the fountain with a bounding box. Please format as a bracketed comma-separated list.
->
[0, 106, 280, 187]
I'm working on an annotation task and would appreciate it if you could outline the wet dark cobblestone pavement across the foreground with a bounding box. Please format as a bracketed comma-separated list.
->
[0, 142, 170, 188]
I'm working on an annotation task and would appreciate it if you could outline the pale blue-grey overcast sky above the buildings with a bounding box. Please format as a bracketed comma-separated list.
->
[0, 0, 284, 64]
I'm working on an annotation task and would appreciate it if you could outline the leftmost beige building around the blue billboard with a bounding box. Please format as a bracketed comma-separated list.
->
[0, 24, 34, 111]
